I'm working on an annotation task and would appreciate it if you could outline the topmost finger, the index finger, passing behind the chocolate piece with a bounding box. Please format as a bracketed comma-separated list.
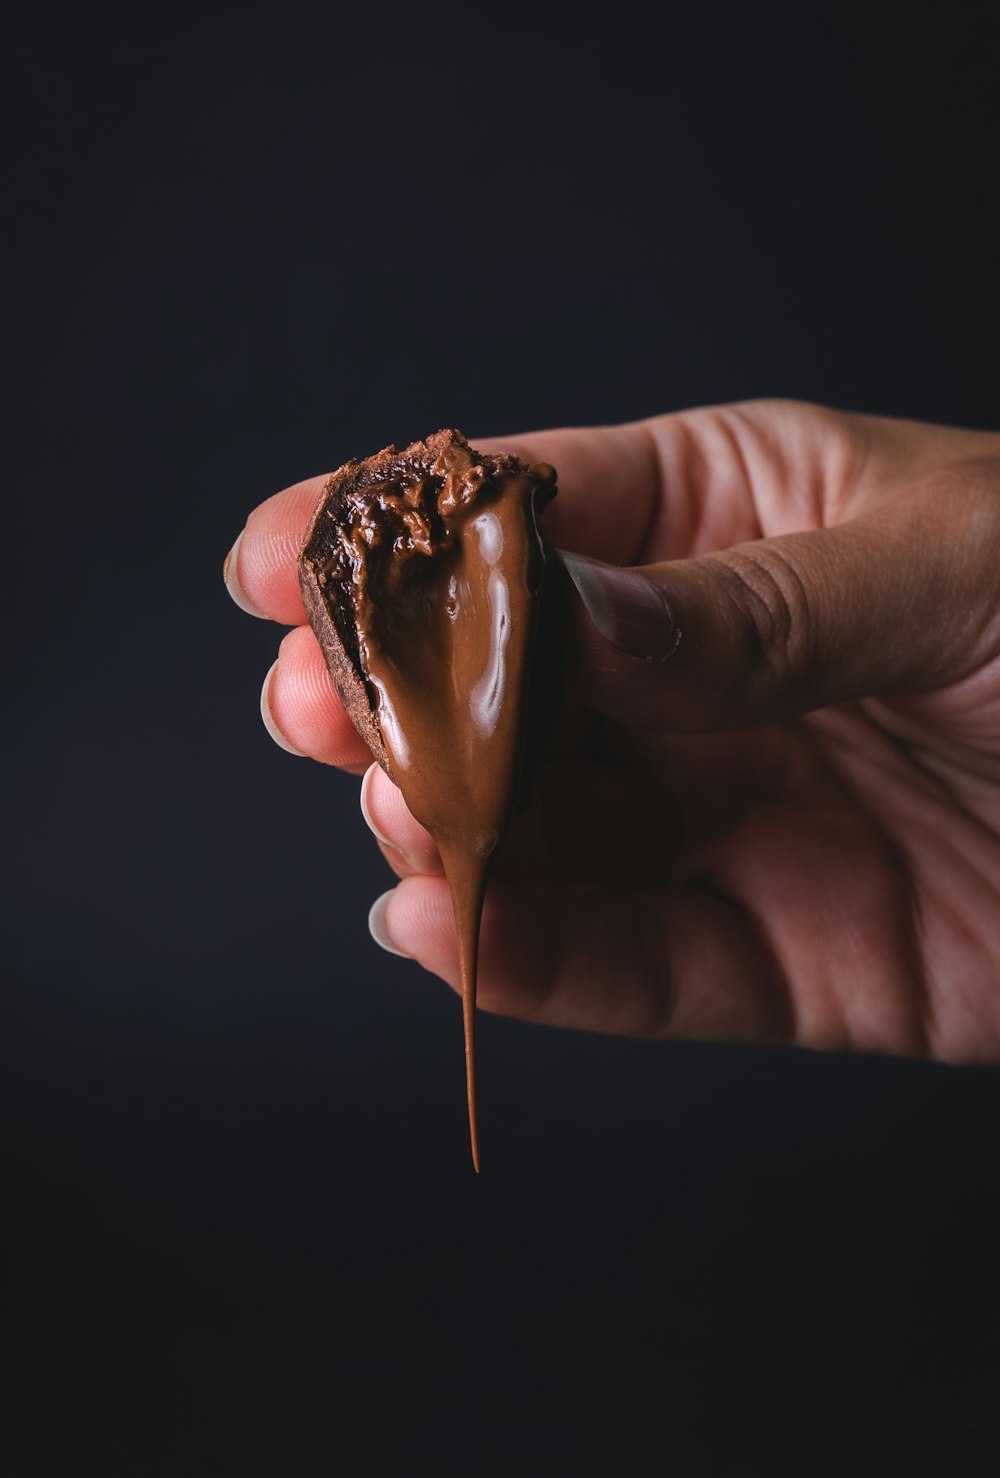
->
[226, 421, 660, 625]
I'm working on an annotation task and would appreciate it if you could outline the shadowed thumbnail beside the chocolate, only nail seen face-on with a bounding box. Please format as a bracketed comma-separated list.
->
[558, 550, 681, 662]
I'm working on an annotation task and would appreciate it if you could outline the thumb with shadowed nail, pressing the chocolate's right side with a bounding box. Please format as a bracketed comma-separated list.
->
[563, 500, 1000, 733]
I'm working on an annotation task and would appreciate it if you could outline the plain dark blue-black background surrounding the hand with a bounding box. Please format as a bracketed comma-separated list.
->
[7, 4, 1000, 1478]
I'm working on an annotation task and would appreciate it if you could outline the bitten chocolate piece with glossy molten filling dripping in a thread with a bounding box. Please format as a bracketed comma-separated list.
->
[298, 430, 555, 1169]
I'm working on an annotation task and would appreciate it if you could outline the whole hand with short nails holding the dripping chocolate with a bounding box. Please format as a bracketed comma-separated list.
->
[230, 402, 1000, 1063]
